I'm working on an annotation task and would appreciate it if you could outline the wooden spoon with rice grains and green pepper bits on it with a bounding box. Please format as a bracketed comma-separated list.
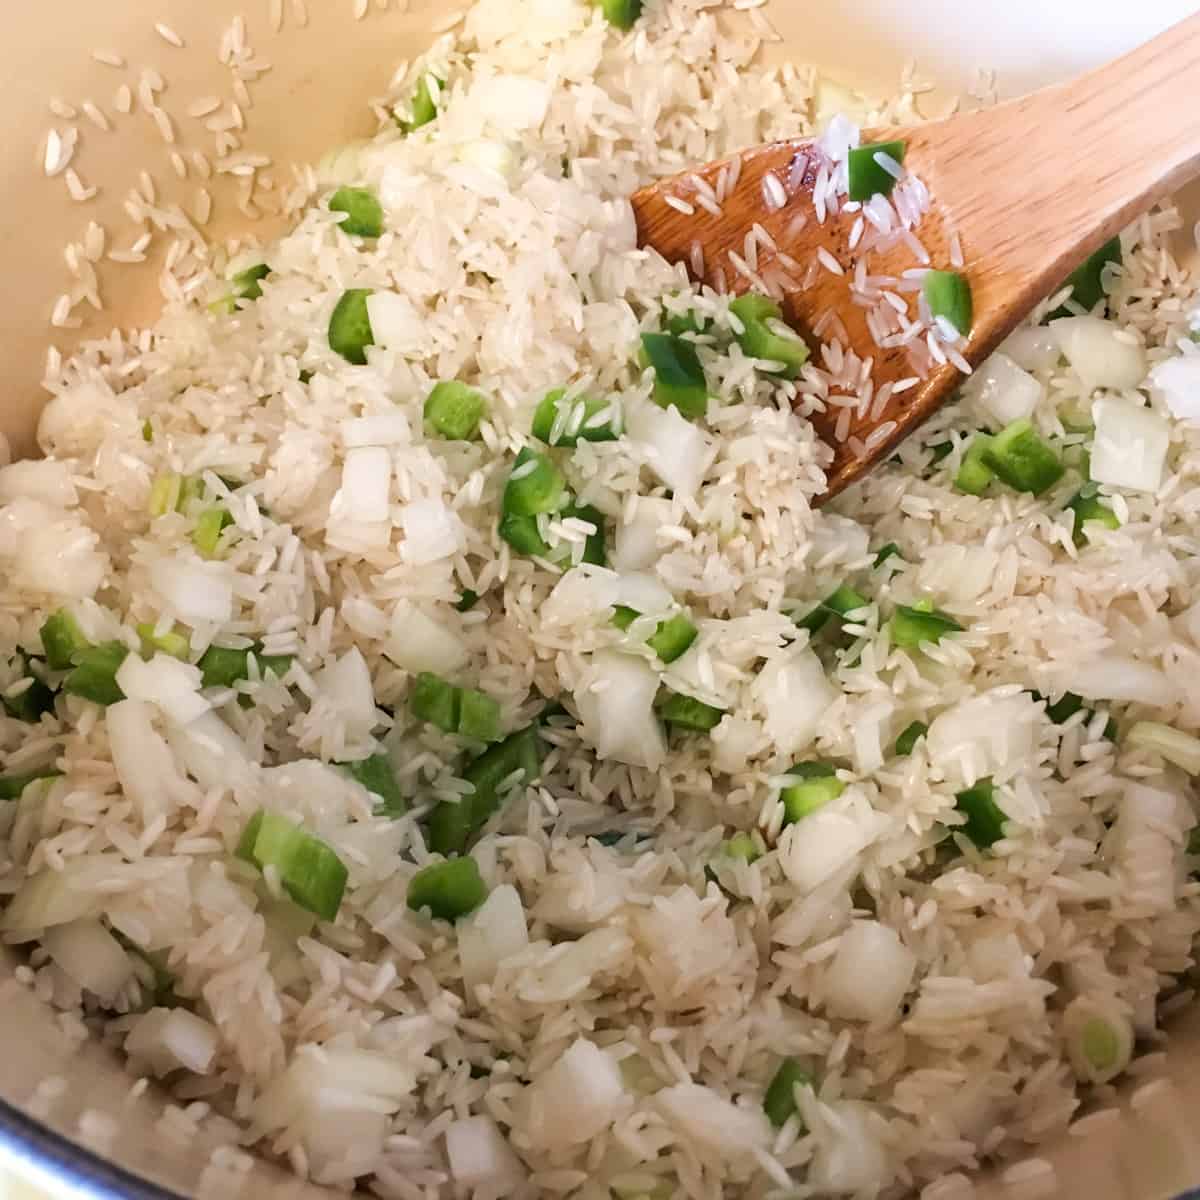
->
[632, 14, 1200, 498]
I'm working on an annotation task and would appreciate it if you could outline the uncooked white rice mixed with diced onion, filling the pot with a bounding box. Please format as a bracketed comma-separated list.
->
[7, 0, 1200, 1200]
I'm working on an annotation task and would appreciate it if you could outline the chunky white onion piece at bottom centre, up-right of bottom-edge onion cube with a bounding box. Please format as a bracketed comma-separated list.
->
[528, 1038, 625, 1146]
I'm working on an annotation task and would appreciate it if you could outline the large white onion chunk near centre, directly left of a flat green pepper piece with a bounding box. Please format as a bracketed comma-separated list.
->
[575, 650, 667, 770]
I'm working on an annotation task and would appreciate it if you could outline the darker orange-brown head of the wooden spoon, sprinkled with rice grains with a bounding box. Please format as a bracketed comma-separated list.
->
[632, 130, 979, 499]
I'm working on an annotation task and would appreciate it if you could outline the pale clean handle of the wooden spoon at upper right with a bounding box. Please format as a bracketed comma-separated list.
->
[908, 14, 1200, 308]
